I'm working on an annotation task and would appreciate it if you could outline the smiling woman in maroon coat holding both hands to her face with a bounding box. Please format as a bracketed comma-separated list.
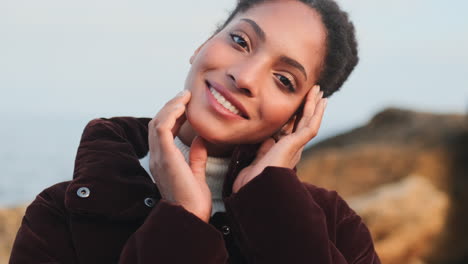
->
[11, 0, 380, 263]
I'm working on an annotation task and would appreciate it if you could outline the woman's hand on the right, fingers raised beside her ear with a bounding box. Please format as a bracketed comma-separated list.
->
[232, 85, 327, 193]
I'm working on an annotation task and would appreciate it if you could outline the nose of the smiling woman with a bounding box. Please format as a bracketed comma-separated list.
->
[227, 58, 266, 97]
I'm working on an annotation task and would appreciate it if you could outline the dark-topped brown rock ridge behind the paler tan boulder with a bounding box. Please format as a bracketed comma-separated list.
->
[298, 108, 468, 198]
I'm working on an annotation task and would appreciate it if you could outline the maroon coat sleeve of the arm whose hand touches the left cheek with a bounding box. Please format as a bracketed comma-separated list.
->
[119, 200, 228, 264]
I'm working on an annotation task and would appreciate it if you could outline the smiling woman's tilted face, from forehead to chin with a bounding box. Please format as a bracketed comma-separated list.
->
[185, 0, 326, 144]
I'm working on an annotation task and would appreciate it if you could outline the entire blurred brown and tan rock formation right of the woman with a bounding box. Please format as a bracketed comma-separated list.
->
[297, 108, 468, 264]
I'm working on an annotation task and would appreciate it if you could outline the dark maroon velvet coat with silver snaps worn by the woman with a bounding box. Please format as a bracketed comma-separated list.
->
[10, 118, 380, 264]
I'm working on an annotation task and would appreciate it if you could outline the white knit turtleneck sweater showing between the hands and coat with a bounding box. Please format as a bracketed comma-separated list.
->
[140, 137, 230, 215]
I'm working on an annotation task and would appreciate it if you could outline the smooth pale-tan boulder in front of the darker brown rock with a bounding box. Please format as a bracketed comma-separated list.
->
[348, 175, 449, 264]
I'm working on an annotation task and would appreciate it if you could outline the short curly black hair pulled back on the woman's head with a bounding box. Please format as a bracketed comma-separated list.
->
[215, 0, 359, 97]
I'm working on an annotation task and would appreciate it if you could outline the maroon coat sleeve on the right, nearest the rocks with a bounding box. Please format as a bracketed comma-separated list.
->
[225, 167, 380, 264]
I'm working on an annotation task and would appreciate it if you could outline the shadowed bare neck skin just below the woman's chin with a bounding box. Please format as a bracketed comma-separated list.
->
[177, 121, 238, 157]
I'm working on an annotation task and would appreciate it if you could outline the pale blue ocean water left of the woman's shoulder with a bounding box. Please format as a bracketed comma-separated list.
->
[0, 116, 92, 207]
